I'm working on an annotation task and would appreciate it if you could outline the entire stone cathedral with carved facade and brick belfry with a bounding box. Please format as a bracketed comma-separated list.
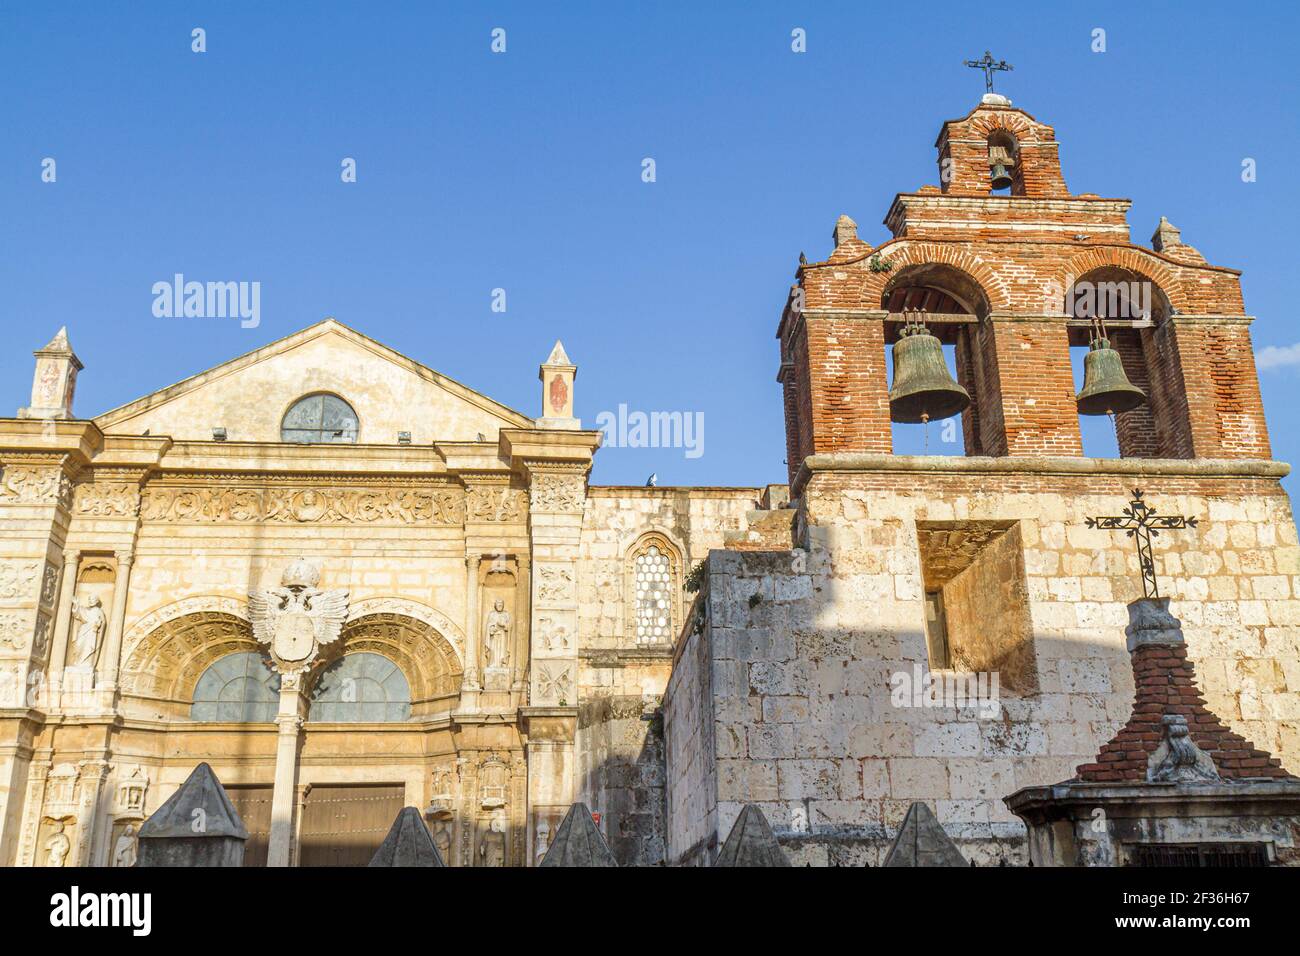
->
[0, 95, 1300, 866]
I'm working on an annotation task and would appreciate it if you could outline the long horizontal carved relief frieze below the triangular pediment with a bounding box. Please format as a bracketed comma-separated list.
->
[140, 488, 465, 525]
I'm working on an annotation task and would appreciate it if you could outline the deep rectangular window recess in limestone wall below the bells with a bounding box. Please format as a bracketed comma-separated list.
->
[917, 520, 1039, 695]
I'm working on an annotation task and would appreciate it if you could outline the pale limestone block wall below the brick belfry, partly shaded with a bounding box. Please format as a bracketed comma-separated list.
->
[666, 467, 1300, 865]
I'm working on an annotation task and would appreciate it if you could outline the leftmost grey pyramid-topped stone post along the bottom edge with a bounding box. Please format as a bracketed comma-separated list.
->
[137, 763, 248, 866]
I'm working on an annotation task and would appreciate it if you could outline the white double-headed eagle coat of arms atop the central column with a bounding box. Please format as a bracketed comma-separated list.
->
[248, 558, 348, 674]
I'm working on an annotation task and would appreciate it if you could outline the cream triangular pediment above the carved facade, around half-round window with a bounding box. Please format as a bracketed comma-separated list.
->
[95, 319, 533, 445]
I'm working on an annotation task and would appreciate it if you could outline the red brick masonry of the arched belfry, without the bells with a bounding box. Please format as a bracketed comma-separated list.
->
[781, 100, 1271, 473]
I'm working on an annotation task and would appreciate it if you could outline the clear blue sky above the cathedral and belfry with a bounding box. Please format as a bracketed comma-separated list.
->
[0, 1, 1300, 485]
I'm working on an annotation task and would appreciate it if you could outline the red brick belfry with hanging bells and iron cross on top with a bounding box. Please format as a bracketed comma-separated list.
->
[777, 82, 1270, 497]
